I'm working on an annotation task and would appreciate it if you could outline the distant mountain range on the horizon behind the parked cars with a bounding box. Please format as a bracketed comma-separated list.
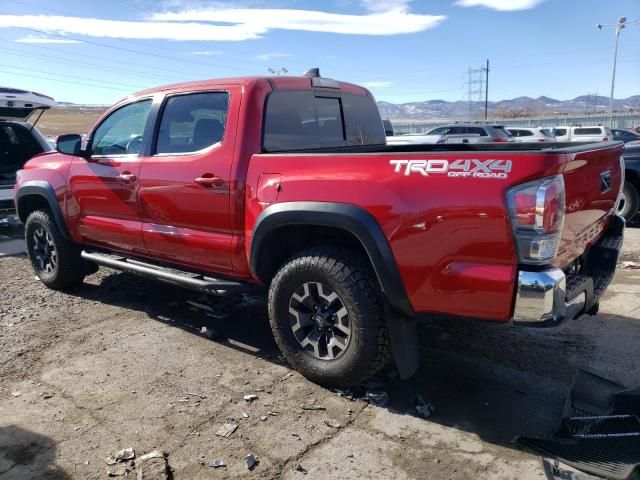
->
[378, 95, 640, 120]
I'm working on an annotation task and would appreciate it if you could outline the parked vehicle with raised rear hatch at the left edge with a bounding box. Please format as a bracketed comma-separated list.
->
[0, 87, 55, 212]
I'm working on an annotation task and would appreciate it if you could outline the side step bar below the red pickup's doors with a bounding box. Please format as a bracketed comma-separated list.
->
[81, 250, 245, 295]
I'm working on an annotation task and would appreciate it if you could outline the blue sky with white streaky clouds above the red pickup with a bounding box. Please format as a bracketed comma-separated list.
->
[0, 0, 640, 104]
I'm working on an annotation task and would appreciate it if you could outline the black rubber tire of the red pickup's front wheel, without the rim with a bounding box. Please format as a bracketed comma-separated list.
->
[24, 210, 88, 290]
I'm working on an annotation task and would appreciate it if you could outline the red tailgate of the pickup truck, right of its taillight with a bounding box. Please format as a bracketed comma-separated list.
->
[555, 142, 624, 267]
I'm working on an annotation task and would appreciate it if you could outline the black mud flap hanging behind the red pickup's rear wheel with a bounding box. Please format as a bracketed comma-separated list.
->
[385, 305, 420, 380]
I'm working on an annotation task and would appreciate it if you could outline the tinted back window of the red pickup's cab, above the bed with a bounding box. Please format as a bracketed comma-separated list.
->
[264, 90, 386, 152]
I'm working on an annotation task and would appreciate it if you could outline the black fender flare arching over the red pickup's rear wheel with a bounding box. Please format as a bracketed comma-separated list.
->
[249, 202, 414, 317]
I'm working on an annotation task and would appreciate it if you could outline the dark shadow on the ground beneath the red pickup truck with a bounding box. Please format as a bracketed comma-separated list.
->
[66, 273, 640, 458]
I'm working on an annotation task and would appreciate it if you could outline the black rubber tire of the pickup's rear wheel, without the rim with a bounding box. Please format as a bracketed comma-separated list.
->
[268, 247, 390, 387]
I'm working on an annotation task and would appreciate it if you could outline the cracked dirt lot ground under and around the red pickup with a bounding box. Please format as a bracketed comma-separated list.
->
[0, 223, 640, 480]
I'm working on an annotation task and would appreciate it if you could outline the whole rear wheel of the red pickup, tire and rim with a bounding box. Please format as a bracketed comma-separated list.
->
[269, 248, 389, 387]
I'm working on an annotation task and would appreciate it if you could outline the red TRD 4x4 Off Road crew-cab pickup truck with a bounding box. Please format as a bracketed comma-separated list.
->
[15, 72, 624, 385]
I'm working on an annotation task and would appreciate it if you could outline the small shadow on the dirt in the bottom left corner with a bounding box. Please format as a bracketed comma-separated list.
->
[0, 425, 72, 480]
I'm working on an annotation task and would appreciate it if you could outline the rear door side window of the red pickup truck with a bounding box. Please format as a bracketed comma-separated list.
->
[155, 92, 229, 154]
